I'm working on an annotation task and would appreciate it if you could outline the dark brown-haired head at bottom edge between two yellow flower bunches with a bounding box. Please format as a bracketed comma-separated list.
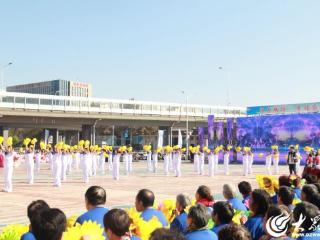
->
[103, 209, 140, 240]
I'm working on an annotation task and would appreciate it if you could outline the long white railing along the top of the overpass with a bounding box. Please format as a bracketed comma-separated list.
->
[0, 91, 246, 117]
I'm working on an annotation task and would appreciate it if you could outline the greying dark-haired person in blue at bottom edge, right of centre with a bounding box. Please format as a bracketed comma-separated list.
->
[185, 204, 218, 240]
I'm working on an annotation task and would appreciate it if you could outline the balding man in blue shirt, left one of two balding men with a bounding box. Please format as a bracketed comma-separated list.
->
[76, 186, 109, 227]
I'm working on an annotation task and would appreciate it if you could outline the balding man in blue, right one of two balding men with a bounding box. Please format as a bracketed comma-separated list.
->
[135, 189, 168, 227]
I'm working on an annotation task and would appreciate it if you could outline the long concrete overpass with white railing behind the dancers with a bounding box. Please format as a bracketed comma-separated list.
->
[0, 91, 246, 145]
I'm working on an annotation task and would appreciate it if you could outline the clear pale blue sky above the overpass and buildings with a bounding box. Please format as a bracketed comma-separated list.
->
[0, 0, 320, 106]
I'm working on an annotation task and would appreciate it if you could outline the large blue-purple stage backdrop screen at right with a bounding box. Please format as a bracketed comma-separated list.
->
[237, 113, 320, 163]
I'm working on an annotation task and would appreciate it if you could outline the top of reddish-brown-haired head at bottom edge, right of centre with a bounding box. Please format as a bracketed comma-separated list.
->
[218, 224, 251, 240]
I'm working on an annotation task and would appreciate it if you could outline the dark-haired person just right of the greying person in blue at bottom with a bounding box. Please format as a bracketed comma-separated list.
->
[212, 202, 234, 235]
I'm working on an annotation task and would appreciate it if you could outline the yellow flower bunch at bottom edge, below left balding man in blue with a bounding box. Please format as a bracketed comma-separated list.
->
[63, 221, 105, 240]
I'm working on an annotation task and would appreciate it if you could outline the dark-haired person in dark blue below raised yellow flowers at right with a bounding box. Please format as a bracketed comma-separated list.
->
[245, 189, 271, 240]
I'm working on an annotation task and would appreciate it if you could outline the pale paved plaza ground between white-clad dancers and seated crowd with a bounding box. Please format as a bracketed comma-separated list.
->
[0, 161, 288, 228]
